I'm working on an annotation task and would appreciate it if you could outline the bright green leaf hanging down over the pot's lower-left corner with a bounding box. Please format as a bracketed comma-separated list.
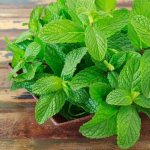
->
[35, 91, 66, 124]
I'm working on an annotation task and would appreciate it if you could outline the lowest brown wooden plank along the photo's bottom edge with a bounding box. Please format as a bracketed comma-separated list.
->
[0, 138, 150, 150]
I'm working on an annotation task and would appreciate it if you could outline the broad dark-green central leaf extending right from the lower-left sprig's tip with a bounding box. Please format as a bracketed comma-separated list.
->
[71, 66, 104, 90]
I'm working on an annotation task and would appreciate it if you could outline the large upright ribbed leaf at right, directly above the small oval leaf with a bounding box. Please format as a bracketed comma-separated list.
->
[118, 55, 141, 92]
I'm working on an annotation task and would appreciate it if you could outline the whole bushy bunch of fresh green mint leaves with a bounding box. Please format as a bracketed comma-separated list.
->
[6, 0, 150, 148]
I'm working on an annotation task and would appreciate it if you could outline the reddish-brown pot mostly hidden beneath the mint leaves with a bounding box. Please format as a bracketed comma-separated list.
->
[8, 63, 92, 130]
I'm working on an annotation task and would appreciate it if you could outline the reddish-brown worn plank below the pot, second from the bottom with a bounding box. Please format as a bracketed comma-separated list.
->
[0, 110, 83, 139]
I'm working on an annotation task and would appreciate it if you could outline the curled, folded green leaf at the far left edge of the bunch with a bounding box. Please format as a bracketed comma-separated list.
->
[14, 62, 41, 82]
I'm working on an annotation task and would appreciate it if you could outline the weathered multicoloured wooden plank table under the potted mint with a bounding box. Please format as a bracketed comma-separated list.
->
[0, 0, 150, 150]
